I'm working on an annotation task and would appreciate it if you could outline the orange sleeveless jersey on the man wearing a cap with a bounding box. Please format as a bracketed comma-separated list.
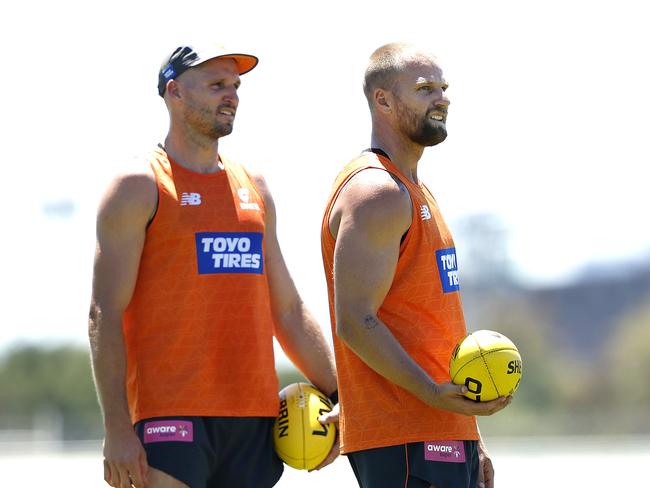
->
[123, 148, 278, 422]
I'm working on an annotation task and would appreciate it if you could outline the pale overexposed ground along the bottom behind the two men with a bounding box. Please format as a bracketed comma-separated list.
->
[0, 437, 650, 488]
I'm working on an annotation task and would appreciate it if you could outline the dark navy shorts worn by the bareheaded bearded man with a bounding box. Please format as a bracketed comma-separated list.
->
[348, 441, 478, 488]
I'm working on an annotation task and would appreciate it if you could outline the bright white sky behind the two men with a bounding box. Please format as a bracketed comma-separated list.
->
[0, 0, 650, 348]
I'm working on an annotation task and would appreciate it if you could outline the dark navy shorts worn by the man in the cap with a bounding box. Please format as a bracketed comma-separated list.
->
[135, 417, 284, 488]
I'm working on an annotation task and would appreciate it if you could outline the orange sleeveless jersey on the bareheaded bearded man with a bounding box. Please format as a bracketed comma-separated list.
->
[321, 153, 479, 453]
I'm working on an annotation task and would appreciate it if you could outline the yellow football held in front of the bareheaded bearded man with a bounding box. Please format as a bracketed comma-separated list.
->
[449, 330, 522, 402]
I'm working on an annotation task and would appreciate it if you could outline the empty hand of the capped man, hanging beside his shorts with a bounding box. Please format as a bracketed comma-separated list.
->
[104, 429, 149, 488]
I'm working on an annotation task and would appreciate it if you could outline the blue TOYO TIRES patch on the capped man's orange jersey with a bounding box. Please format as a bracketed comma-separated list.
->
[196, 232, 264, 274]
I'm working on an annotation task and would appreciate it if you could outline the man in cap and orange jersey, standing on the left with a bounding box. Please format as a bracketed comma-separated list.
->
[89, 46, 338, 488]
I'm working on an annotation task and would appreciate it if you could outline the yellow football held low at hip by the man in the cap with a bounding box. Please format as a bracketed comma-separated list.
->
[273, 383, 336, 469]
